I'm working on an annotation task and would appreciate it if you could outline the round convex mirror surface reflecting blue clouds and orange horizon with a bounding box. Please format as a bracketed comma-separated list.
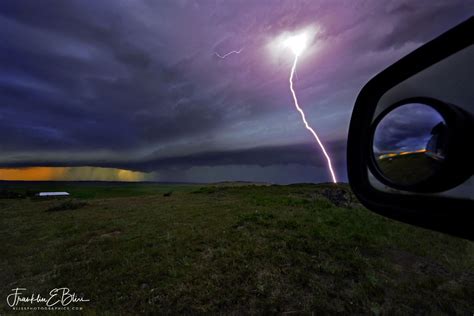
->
[373, 103, 447, 186]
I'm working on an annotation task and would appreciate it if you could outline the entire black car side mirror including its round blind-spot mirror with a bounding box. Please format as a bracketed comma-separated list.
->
[347, 17, 474, 240]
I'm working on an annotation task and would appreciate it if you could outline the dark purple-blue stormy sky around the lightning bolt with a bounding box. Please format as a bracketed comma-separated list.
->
[0, 0, 474, 183]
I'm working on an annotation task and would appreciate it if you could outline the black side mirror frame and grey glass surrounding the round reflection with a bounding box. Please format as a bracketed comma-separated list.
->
[347, 17, 474, 240]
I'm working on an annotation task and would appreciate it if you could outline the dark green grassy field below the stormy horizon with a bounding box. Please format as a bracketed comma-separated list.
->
[0, 183, 474, 315]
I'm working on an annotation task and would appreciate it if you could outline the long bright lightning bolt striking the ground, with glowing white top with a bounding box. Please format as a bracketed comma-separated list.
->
[286, 34, 337, 183]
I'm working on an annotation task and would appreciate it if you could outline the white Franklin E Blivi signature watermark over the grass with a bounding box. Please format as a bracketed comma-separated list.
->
[7, 287, 90, 310]
